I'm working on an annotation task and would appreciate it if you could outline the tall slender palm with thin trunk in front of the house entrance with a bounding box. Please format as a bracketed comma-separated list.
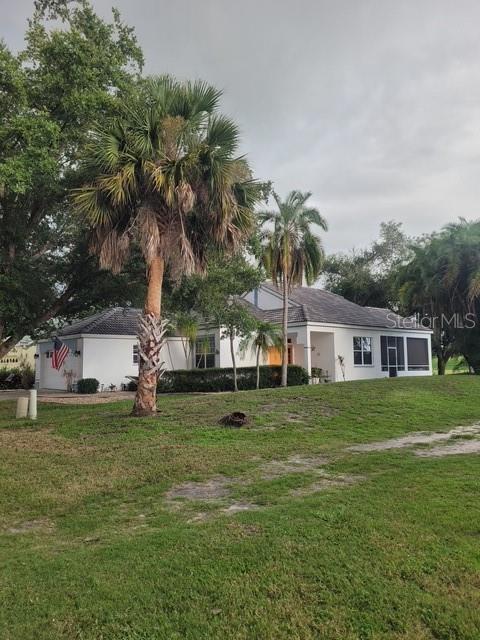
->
[260, 191, 328, 387]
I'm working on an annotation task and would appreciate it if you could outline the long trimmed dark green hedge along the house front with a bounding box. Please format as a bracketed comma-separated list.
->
[158, 364, 308, 393]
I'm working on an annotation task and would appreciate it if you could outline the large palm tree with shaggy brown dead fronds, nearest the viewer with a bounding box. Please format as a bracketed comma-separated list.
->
[74, 76, 259, 415]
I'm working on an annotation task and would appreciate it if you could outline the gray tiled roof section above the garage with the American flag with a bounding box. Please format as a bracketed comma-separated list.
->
[58, 307, 141, 336]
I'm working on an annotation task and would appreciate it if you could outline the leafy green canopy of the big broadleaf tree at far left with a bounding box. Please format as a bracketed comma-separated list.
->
[0, 0, 143, 355]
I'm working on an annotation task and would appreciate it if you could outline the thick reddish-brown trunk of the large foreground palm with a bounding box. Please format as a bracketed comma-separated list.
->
[132, 256, 165, 416]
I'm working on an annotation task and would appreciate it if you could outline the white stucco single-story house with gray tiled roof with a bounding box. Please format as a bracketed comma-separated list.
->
[36, 284, 432, 389]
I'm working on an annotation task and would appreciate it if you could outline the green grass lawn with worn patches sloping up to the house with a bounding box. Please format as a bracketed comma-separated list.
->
[0, 376, 480, 640]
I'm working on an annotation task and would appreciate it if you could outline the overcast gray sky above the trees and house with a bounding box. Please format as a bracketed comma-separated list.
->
[0, 0, 480, 251]
